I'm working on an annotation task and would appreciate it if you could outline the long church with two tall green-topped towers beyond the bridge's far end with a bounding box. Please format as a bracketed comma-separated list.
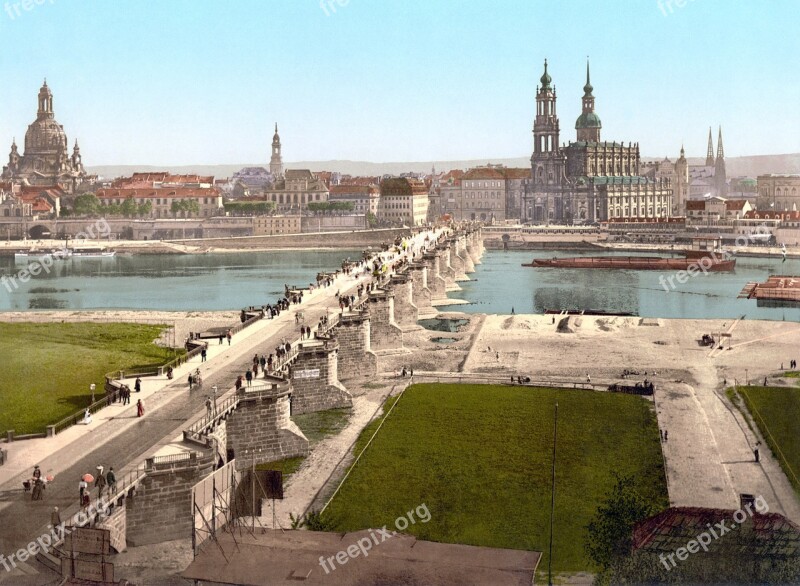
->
[521, 60, 672, 224]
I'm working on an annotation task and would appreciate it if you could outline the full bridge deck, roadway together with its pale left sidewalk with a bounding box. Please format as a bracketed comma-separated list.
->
[0, 230, 444, 583]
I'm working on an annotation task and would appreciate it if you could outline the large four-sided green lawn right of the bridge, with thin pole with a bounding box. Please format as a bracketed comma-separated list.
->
[324, 385, 668, 571]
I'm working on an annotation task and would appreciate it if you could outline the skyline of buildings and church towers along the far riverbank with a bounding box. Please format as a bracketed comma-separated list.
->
[0, 74, 800, 234]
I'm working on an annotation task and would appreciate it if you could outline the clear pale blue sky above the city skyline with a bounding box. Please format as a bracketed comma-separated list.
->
[0, 0, 800, 167]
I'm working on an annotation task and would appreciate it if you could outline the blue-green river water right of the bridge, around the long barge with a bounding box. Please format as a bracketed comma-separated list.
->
[449, 250, 800, 321]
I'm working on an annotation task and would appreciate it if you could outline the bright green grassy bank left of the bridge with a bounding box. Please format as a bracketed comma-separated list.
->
[0, 323, 173, 434]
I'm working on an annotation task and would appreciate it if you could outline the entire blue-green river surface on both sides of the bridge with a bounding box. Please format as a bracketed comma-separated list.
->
[0, 250, 800, 322]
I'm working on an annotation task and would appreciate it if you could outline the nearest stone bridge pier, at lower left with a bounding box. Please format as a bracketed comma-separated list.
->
[125, 452, 214, 546]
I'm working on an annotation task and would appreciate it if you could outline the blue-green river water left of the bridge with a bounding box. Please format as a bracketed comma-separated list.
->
[0, 250, 361, 311]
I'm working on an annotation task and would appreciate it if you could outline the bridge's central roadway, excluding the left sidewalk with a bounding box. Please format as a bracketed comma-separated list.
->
[0, 226, 444, 583]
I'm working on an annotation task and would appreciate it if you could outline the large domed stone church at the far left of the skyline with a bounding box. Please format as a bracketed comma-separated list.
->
[2, 80, 87, 193]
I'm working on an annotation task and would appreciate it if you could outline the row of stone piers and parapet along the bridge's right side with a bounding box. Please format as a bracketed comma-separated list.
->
[31, 226, 483, 567]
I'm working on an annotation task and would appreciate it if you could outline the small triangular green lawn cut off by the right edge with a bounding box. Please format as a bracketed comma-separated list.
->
[739, 386, 800, 493]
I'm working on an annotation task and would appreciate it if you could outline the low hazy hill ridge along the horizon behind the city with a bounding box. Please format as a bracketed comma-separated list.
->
[87, 153, 800, 179]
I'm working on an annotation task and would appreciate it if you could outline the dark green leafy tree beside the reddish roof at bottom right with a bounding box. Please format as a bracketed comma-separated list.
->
[584, 472, 653, 583]
